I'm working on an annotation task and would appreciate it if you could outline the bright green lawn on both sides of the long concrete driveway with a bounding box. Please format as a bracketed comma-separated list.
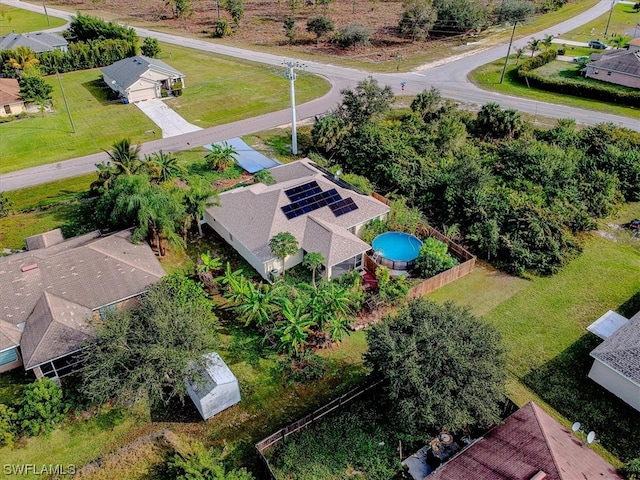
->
[0, 41, 329, 173]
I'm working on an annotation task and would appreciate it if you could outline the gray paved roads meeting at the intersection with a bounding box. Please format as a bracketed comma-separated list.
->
[0, 0, 640, 191]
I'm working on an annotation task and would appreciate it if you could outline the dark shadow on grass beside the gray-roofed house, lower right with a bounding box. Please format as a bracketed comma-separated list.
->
[523, 333, 640, 461]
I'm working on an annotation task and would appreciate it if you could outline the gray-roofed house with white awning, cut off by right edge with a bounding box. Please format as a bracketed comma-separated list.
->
[588, 312, 640, 411]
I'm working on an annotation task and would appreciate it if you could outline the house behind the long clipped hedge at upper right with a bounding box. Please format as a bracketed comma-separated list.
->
[585, 49, 640, 88]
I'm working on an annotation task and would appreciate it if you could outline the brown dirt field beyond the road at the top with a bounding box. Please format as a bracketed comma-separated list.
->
[49, 0, 460, 63]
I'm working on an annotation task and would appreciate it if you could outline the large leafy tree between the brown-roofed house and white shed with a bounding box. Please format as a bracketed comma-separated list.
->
[82, 274, 216, 406]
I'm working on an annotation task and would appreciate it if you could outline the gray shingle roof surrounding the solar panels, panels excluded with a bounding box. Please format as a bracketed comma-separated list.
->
[207, 159, 389, 265]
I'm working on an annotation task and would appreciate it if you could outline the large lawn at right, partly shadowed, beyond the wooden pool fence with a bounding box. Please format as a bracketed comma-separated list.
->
[429, 203, 640, 459]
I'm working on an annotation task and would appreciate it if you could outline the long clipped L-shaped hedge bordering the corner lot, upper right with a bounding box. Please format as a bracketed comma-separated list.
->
[517, 50, 640, 107]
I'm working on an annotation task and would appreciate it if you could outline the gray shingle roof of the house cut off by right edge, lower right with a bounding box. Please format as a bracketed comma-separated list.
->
[591, 312, 640, 385]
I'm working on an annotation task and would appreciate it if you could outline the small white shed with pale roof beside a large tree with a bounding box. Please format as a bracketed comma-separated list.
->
[186, 352, 240, 420]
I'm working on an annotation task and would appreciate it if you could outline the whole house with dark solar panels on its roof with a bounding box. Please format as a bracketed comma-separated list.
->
[205, 159, 389, 279]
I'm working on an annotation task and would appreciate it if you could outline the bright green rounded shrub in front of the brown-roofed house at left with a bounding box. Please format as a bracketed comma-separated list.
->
[17, 378, 69, 436]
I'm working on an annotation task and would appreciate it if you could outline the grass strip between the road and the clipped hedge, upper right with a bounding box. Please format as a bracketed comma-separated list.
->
[469, 57, 640, 118]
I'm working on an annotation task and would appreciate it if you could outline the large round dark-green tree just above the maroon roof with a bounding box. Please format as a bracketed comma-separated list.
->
[365, 298, 506, 438]
